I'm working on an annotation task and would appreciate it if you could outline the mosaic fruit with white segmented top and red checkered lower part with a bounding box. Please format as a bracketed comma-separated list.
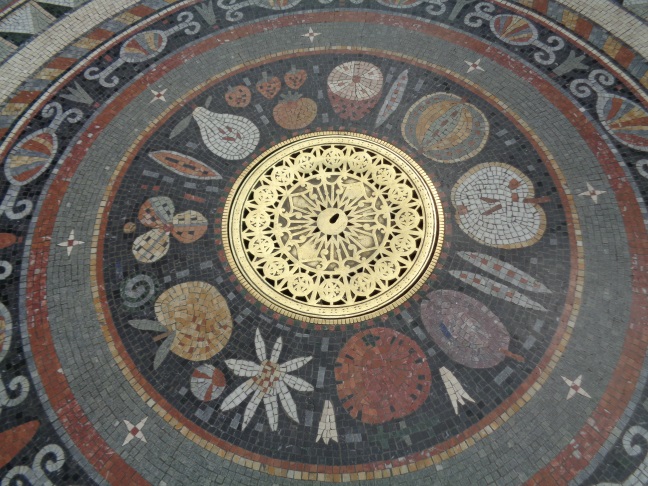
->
[327, 61, 383, 121]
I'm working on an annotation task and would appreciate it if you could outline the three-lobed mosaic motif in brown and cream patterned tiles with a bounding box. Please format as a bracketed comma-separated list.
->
[133, 197, 207, 263]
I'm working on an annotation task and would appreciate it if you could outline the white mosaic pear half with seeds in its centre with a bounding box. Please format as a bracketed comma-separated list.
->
[193, 108, 259, 160]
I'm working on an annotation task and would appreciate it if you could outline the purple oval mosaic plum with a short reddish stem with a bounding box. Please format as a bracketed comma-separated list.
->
[421, 290, 521, 368]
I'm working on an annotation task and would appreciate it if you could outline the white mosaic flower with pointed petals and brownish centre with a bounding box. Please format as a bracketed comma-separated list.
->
[221, 328, 314, 431]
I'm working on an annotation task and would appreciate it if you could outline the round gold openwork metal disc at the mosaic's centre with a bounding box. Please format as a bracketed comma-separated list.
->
[223, 132, 443, 324]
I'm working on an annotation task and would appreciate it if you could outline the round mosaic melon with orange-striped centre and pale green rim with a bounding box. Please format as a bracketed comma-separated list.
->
[402, 93, 489, 163]
